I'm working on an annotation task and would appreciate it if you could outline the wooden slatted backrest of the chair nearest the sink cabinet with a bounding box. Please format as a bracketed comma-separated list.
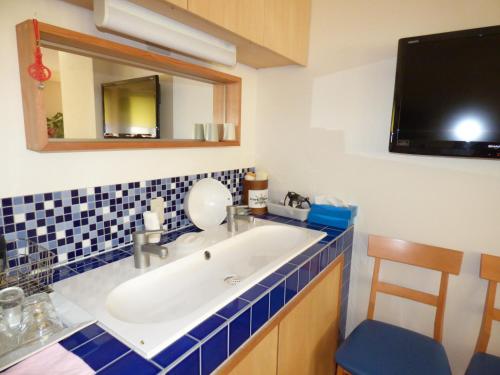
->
[368, 235, 463, 342]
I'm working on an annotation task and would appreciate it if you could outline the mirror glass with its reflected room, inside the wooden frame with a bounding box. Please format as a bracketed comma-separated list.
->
[42, 47, 222, 141]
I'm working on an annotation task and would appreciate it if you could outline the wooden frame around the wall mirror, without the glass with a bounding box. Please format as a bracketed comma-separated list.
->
[16, 20, 241, 152]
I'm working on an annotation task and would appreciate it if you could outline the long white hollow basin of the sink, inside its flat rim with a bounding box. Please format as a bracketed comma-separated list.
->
[106, 225, 320, 324]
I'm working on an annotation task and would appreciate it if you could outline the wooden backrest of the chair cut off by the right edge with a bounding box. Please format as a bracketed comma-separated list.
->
[476, 254, 500, 352]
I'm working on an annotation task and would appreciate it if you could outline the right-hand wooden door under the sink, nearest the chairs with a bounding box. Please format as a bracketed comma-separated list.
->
[278, 263, 342, 375]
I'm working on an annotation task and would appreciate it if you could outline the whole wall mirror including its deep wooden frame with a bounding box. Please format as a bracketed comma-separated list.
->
[16, 20, 241, 151]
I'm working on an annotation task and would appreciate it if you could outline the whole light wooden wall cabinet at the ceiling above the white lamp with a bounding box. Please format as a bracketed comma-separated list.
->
[65, 0, 311, 68]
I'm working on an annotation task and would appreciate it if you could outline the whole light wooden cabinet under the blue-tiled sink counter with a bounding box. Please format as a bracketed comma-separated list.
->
[219, 257, 344, 375]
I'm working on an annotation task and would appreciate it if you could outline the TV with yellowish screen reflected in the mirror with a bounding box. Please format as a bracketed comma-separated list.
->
[102, 75, 160, 138]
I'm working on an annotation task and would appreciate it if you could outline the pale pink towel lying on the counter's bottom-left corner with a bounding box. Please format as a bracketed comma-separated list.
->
[5, 344, 95, 375]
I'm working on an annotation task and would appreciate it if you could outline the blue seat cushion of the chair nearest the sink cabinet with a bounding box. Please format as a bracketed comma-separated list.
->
[336, 320, 451, 375]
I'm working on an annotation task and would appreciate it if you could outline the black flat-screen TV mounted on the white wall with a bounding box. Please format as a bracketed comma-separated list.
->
[389, 26, 500, 159]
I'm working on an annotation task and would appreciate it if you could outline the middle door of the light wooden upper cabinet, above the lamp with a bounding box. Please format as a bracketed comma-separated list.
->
[188, 0, 266, 44]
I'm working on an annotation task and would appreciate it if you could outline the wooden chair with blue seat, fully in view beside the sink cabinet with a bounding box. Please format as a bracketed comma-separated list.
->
[336, 236, 463, 375]
